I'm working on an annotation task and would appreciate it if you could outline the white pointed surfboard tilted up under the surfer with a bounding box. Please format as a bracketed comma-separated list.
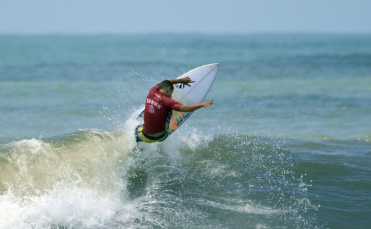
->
[138, 63, 218, 138]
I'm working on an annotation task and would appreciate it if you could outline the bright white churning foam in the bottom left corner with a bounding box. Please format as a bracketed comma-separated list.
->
[0, 183, 124, 229]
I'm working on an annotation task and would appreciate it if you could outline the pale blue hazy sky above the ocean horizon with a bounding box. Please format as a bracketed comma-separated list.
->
[0, 0, 371, 34]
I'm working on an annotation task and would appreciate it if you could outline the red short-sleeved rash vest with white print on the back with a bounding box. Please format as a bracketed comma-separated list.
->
[143, 84, 182, 134]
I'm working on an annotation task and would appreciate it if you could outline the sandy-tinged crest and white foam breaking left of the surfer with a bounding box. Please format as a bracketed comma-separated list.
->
[0, 129, 140, 229]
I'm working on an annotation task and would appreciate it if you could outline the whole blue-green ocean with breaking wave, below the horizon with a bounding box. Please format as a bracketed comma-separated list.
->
[0, 34, 371, 229]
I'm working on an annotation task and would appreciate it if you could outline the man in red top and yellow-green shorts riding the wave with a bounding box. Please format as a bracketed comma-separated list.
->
[135, 77, 214, 143]
